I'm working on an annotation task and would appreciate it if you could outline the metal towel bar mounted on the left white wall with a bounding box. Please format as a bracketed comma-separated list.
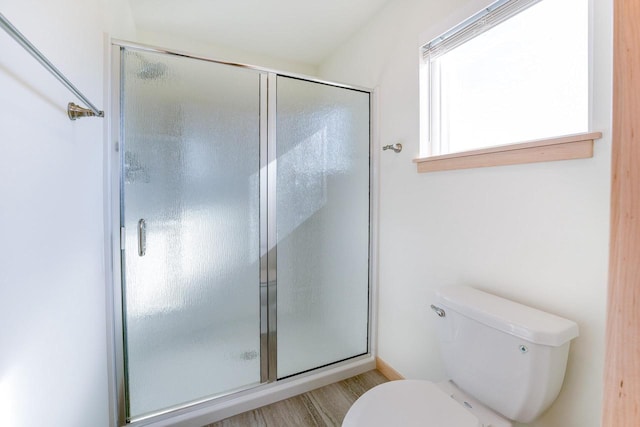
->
[0, 13, 104, 120]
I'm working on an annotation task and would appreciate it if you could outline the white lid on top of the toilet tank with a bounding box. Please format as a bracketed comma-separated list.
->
[436, 286, 578, 347]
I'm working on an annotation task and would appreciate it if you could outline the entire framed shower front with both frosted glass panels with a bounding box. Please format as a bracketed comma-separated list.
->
[112, 43, 371, 423]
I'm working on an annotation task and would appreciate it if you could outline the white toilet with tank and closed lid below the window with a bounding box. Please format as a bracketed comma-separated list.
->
[342, 286, 578, 427]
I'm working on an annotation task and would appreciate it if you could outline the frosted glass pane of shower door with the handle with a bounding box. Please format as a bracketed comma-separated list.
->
[121, 50, 260, 418]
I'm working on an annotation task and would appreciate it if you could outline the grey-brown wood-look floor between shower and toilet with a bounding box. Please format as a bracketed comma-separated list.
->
[205, 370, 388, 427]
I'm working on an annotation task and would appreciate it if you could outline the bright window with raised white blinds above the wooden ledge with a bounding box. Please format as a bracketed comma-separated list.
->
[421, 0, 589, 156]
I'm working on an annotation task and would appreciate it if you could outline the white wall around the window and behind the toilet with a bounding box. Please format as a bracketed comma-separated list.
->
[319, 0, 612, 427]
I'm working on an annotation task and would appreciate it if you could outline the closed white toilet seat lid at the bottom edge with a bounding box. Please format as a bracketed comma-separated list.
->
[342, 380, 483, 427]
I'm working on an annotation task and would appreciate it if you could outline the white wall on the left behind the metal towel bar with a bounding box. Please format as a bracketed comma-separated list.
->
[0, 0, 132, 427]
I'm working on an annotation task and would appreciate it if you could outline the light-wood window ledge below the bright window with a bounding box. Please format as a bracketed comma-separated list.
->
[413, 132, 602, 173]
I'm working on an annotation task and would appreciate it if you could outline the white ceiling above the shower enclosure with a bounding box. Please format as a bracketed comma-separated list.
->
[129, 0, 390, 66]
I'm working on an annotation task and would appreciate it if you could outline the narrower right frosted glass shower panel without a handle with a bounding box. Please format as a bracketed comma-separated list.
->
[276, 77, 369, 378]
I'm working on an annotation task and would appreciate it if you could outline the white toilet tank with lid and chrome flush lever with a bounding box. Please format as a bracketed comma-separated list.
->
[432, 286, 578, 423]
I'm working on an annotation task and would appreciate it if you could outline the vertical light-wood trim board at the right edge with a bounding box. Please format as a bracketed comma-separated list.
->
[602, 0, 640, 427]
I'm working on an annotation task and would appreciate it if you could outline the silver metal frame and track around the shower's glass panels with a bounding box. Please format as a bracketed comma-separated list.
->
[105, 39, 377, 426]
